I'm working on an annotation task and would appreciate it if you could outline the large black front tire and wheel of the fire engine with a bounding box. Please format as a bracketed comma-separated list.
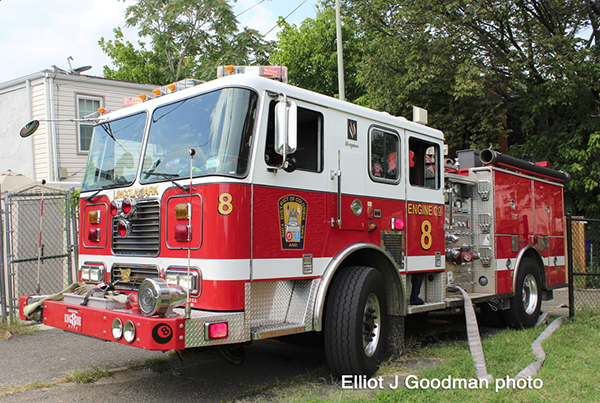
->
[324, 266, 387, 378]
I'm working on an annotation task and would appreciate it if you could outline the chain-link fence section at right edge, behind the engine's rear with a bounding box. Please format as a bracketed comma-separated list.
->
[567, 215, 600, 317]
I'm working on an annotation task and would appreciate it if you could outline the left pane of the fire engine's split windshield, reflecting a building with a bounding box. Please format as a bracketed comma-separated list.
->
[81, 113, 146, 190]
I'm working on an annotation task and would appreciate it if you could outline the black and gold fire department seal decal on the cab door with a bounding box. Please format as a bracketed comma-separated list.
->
[279, 195, 308, 250]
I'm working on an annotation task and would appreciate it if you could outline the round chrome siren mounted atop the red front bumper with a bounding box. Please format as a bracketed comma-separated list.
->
[138, 278, 187, 316]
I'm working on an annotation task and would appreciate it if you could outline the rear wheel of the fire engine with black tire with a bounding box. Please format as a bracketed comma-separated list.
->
[503, 258, 542, 329]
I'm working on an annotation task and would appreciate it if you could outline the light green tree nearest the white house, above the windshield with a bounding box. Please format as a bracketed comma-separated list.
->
[99, 0, 273, 84]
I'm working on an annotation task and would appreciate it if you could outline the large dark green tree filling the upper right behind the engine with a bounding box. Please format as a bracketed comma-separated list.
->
[344, 0, 600, 213]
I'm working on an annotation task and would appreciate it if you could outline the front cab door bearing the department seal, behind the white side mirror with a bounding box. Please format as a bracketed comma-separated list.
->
[252, 94, 329, 281]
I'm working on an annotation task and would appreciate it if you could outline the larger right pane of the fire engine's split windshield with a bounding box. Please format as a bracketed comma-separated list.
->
[142, 88, 258, 183]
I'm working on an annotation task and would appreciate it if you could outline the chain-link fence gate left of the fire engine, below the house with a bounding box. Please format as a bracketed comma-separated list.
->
[0, 191, 77, 319]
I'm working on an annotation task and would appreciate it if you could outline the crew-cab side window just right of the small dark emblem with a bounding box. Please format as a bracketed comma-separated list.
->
[369, 127, 400, 183]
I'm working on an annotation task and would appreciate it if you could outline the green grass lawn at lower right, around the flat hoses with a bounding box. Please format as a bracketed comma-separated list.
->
[237, 310, 600, 403]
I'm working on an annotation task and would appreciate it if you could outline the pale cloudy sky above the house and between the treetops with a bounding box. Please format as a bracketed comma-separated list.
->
[0, 0, 318, 83]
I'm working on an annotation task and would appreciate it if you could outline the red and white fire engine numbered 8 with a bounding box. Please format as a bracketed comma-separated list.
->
[20, 68, 568, 376]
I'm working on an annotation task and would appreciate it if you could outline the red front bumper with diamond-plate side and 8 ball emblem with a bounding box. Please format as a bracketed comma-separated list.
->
[19, 296, 250, 351]
